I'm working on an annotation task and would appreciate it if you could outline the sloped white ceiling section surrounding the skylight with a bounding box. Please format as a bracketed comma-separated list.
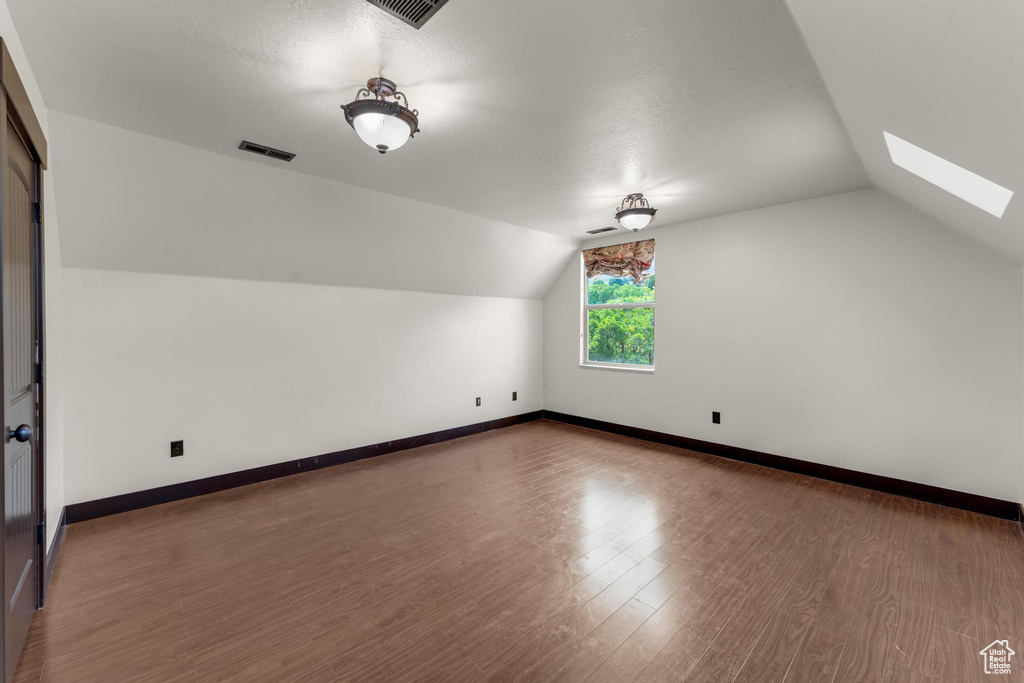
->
[788, 0, 1024, 263]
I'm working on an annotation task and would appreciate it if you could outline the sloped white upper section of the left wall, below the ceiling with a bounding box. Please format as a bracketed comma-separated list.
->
[50, 112, 575, 299]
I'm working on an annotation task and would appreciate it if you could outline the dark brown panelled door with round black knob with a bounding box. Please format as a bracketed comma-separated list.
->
[0, 120, 40, 681]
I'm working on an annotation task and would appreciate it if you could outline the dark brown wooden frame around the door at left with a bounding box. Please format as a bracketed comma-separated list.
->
[0, 37, 47, 683]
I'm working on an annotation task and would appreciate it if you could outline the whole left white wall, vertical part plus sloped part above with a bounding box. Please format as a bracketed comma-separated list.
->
[50, 112, 561, 503]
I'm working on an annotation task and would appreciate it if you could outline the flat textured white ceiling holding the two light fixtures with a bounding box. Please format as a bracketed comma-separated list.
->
[8, 0, 869, 237]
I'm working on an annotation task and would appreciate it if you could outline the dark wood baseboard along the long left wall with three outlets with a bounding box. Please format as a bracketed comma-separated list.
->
[66, 411, 542, 524]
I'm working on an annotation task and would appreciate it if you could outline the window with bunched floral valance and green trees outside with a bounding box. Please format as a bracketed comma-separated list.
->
[581, 240, 654, 371]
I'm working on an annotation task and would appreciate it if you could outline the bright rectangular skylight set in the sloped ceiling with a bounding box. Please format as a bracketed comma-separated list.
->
[883, 131, 1014, 218]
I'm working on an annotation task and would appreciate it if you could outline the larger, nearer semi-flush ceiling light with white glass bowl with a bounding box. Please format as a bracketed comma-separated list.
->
[341, 78, 420, 155]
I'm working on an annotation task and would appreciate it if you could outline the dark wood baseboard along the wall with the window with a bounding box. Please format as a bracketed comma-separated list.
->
[544, 411, 1024, 520]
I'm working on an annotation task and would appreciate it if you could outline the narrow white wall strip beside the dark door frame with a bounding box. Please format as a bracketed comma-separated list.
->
[0, 0, 65, 548]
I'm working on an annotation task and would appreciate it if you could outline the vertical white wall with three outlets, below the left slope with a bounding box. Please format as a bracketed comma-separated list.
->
[65, 268, 543, 503]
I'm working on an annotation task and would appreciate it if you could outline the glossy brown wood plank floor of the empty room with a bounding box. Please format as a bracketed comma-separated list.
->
[9, 421, 1024, 683]
